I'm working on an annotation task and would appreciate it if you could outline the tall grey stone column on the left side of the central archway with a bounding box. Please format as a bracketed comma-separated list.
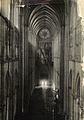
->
[19, 7, 24, 111]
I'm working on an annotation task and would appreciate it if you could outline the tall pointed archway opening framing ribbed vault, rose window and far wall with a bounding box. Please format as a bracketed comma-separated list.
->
[29, 4, 61, 88]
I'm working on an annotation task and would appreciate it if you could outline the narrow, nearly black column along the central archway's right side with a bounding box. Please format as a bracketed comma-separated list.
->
[60, 25, 65, 113]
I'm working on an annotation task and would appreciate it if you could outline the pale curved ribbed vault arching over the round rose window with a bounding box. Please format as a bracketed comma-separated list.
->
[29, 5, 60, 35]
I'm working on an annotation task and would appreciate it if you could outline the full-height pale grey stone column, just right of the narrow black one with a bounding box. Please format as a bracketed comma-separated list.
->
[64, 1, 70, 119]
